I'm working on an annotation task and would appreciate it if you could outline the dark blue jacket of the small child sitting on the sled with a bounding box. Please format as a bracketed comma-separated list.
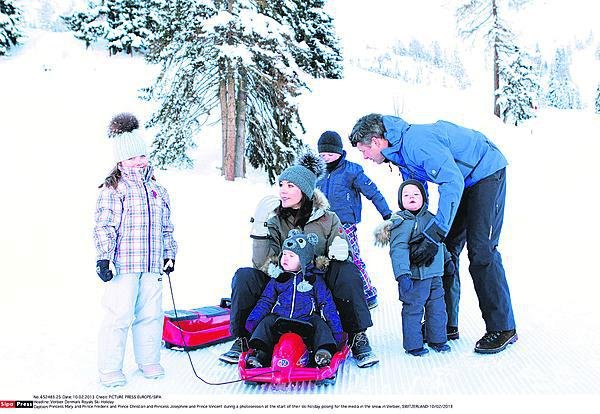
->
[246, 264, 343, 335]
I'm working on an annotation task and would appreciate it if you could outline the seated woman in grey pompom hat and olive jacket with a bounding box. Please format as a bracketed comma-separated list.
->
[219, 153, 379, 368]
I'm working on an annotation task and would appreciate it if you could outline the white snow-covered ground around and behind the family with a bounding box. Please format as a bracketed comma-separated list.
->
[0, 21, 600, 413]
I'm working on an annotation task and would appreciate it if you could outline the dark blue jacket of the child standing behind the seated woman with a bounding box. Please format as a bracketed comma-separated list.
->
[317, 151, 392, 224]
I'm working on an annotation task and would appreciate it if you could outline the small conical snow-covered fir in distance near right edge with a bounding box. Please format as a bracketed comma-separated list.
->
[545, 48, 582, 109]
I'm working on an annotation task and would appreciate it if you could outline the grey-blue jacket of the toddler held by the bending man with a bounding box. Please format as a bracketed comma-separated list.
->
[389, 206, 446, 279]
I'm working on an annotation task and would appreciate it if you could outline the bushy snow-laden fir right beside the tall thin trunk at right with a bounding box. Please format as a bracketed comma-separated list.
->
[496, 46, 540, 125]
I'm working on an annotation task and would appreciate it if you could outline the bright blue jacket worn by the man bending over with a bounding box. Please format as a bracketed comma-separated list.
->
[381, 116, 508, 243]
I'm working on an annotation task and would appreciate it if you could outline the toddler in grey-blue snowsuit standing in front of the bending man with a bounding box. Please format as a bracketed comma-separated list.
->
[376, 180, 450, 356]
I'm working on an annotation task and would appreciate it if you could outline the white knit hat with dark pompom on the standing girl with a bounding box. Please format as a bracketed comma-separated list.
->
[108, 112, 148, 163]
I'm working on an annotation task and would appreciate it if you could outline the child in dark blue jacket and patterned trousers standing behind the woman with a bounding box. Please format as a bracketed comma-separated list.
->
[317, 131, 392, 308]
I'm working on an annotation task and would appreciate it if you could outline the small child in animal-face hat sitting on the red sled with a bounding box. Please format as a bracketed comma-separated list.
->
[246, 229, 342, 368]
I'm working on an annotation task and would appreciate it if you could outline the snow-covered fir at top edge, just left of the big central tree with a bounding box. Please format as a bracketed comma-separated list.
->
[63, 0, 162, 55]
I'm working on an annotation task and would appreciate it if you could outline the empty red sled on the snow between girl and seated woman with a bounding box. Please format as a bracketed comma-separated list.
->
[163, 298, 233, 351]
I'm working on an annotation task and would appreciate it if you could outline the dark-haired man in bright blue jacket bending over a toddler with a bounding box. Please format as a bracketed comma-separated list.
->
[350, 114, 518, 354]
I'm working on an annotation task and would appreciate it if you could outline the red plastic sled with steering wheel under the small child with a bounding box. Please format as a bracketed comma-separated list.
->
[238, 318, 350, 385]
